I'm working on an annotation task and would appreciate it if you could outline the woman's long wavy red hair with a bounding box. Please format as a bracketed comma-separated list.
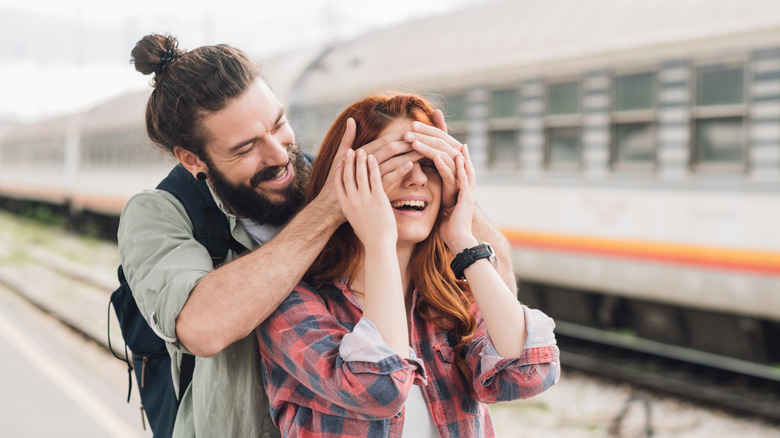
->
[306, 94, 477, 384]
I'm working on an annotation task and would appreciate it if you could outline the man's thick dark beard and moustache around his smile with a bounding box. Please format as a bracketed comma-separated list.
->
[204, 145, 310, 227]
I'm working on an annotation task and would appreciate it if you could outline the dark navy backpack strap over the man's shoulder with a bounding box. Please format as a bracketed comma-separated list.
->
[157, 164, 249, 401]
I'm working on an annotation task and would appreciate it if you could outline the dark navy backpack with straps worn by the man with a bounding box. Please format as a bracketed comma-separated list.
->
[108, 164, 248, 437]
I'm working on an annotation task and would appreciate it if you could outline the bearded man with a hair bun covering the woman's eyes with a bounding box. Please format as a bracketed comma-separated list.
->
[118, 35, 516, 437]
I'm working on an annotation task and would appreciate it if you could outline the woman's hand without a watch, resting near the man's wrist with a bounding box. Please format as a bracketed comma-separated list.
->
[335, 149, 398, 249]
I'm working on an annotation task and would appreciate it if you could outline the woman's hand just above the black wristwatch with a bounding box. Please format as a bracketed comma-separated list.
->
[433, 145, 477, 254]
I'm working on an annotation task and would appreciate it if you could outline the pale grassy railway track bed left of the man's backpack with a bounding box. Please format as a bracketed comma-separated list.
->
[0, 213, 124, 355]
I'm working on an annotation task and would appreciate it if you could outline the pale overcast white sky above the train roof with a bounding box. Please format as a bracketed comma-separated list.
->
[0, 0, 485, 122]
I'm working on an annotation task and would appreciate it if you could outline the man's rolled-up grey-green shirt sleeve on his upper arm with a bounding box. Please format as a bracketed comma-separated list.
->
[117, 190, 213, 351]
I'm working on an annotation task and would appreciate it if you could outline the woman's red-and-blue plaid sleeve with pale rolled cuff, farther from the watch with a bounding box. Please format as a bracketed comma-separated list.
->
[257, 283, 424, 419]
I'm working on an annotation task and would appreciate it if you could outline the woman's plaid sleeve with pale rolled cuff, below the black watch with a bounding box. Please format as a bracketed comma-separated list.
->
[466, 302, 560, 403]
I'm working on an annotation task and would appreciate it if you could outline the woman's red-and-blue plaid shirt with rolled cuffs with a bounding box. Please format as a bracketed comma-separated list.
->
[257, 282, 560, 438]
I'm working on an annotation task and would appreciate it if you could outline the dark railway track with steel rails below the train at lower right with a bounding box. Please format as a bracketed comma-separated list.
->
[556, 321, 780, 424]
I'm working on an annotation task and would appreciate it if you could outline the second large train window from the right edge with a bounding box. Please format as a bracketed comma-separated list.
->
[610, 72, 656, 170]
